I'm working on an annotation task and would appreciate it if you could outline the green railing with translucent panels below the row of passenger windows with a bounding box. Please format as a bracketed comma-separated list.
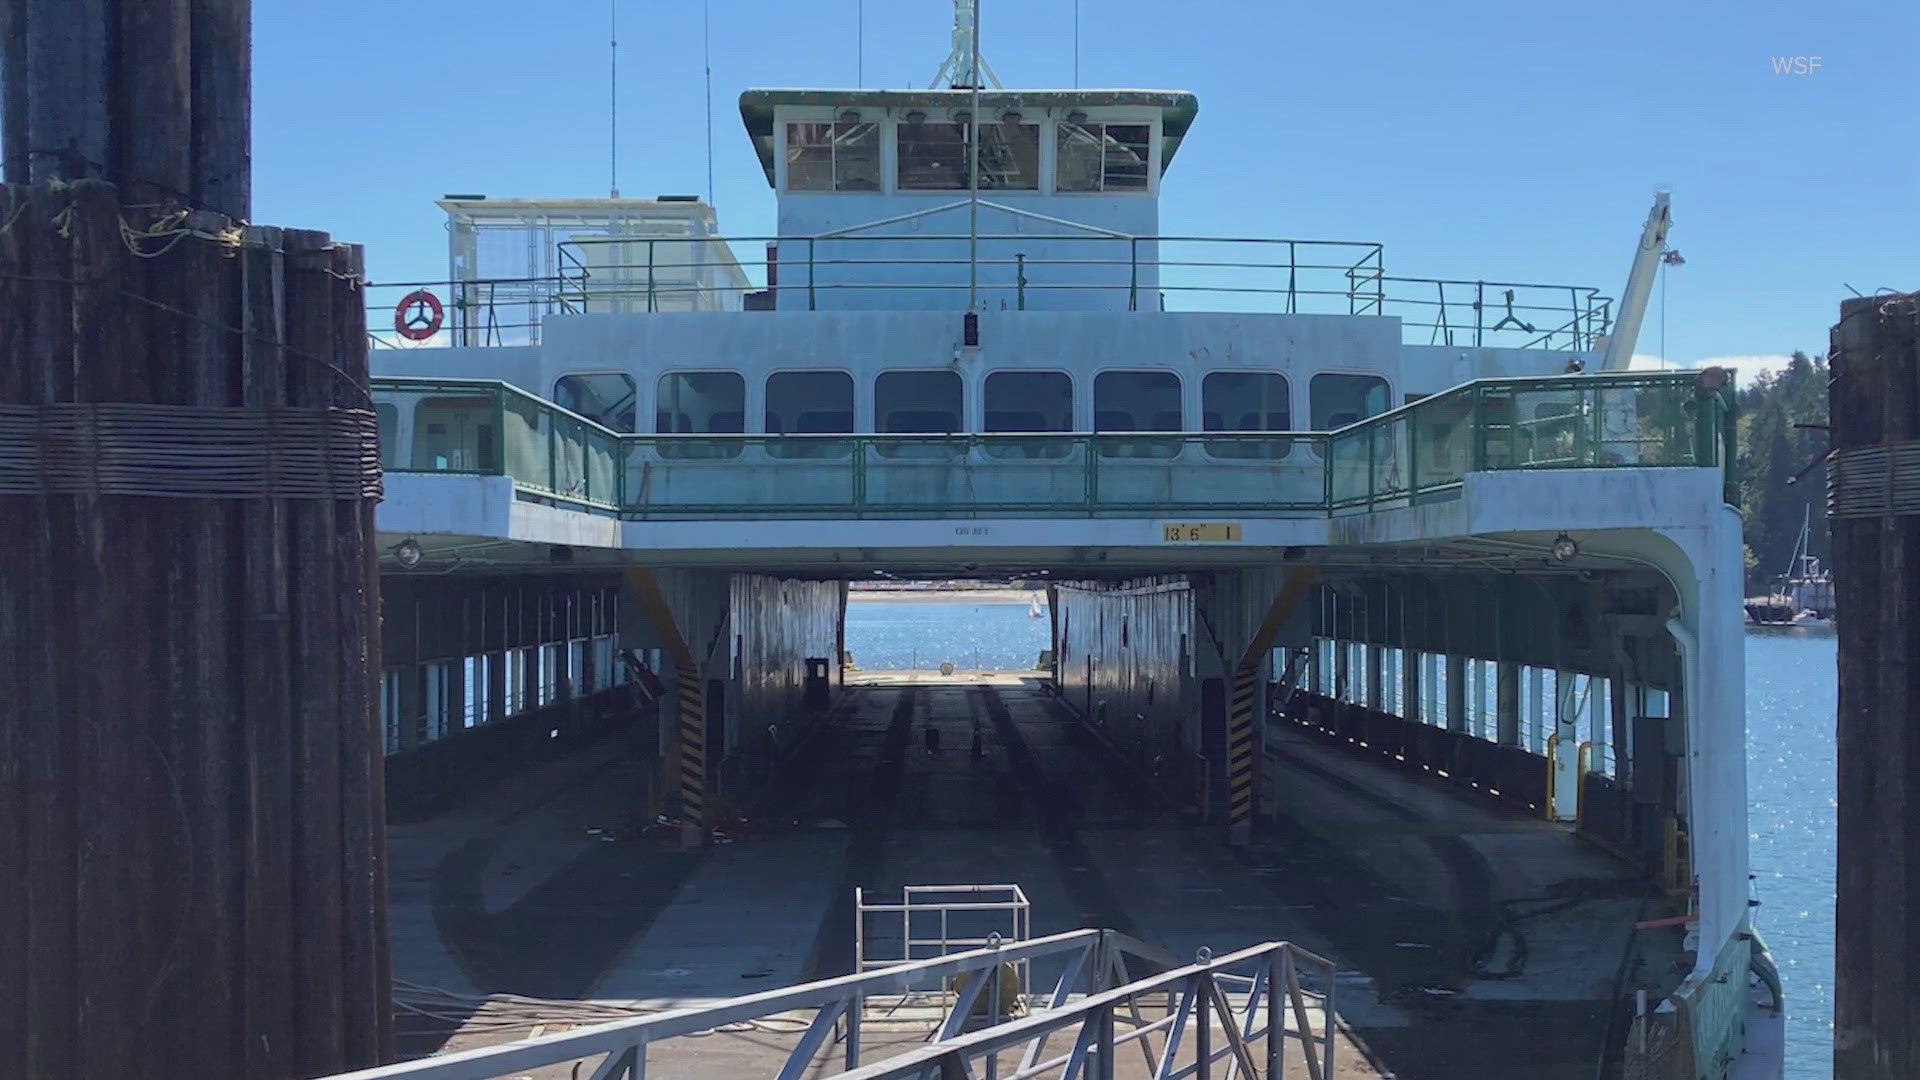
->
[374, 373, 1732, 519]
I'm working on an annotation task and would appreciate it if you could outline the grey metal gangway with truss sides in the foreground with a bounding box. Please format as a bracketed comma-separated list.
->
[322, 930, 1334, 1080]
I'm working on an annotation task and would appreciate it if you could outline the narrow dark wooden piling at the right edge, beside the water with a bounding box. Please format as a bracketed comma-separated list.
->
[1826, 292, 1920, 1080]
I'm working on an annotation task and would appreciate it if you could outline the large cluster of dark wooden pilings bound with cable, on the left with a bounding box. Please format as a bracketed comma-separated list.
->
[0, 0, 392, 1080]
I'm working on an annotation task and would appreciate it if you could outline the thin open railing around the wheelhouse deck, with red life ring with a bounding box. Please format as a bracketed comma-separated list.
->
[367, 233, 1613, 352]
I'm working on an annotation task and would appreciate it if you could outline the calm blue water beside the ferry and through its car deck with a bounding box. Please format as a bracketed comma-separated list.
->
[847, 601, 1836, 1080]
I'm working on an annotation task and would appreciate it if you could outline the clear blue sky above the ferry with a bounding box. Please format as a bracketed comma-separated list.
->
[253, 0, 1920, 373]
